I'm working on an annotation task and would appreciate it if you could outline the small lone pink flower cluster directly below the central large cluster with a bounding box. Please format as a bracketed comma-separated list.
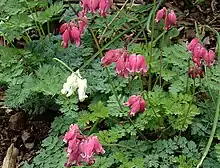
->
[124, 95, 146, 116]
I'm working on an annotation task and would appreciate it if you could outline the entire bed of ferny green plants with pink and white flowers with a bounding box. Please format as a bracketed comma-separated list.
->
[0, 0, 220, 168]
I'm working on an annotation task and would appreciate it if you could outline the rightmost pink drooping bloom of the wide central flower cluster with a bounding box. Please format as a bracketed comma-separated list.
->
[127, 54, 147, 75]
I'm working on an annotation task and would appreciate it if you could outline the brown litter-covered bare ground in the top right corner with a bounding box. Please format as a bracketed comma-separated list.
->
[165, 0, 220, 48]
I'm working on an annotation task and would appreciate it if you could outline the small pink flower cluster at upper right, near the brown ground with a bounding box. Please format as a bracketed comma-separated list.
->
[155, 7, 177, 30]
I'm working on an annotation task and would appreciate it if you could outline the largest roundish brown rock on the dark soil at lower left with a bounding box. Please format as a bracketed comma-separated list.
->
[9, 112, 25, 131]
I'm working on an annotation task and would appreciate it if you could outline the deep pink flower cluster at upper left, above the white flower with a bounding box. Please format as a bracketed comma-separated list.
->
[60, 12, 88, 48]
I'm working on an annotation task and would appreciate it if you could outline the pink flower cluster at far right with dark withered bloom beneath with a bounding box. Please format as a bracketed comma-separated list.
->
[186, 38, 215, 78]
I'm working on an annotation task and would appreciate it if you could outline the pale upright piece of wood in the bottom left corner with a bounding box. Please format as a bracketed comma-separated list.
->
[2, 143, 19, 168]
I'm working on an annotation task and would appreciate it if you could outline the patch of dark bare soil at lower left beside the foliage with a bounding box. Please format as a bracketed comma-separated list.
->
[0, 90, 50, 165]
